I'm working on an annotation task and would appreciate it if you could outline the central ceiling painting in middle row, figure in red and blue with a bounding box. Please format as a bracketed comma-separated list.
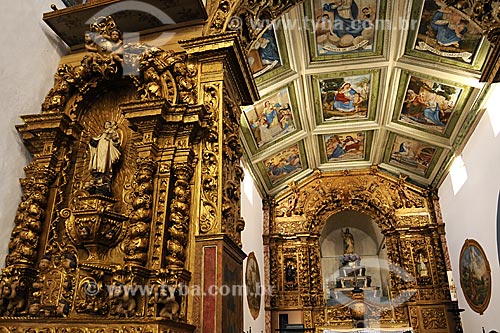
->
[312, 70, 380, 124]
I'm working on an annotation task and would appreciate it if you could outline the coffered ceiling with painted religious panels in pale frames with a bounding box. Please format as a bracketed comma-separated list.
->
[241, 0, 490, 194]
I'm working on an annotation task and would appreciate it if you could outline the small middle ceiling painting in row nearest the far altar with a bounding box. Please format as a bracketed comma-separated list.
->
[318, 131, 373, 163]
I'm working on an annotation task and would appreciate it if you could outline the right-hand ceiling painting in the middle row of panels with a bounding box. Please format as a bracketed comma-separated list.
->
[393, 71, 471, 137]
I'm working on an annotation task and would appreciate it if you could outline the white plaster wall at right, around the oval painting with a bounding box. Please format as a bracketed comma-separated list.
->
[439, 85, 500, 332]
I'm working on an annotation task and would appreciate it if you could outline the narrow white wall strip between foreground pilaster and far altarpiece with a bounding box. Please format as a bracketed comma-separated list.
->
[241, 166, 265, 333]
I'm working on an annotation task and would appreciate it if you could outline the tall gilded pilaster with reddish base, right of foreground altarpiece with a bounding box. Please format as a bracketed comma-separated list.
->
[182, 34, 258, 333]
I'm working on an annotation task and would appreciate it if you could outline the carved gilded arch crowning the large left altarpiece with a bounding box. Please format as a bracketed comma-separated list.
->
[42, 17, 197, 118]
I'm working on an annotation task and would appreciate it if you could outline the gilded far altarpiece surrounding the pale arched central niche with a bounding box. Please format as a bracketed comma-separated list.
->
[264, 167, 453, 332]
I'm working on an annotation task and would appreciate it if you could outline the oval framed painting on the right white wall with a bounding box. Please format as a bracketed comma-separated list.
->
[460, 239, 491, 314]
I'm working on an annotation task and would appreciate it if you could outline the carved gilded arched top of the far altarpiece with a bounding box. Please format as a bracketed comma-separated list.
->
[271, 170, 428, 234]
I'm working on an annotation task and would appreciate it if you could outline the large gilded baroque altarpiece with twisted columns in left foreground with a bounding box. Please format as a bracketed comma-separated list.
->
[0, 13, 257, 333]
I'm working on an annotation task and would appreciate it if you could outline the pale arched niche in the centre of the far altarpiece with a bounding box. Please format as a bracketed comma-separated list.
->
[319, 210, 389, 305]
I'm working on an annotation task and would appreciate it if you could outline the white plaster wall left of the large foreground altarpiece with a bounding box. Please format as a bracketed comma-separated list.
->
[0, 0, 65, 267]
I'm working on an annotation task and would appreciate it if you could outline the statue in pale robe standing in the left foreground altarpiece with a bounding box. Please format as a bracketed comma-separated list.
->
[89, 121, 121, 195]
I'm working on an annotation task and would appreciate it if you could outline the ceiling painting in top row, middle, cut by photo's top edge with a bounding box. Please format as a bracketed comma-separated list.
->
[305, 0, 389, 61]
